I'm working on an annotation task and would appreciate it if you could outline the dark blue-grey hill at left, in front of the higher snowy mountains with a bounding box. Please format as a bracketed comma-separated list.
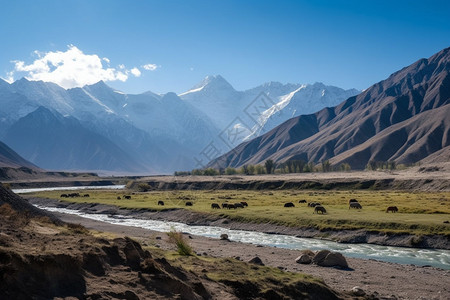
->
[4, 107, 146, 171]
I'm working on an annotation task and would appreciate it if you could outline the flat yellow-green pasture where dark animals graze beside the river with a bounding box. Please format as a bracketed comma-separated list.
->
[30, 190, 450, 235]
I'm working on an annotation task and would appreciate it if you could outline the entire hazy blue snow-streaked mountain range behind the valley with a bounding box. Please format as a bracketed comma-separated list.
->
[0, 75, 358, 174]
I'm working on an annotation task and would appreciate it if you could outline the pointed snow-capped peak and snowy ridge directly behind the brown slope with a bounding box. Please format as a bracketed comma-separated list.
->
[178, 75, 359, 151]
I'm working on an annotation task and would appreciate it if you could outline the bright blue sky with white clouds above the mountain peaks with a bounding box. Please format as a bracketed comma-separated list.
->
[0, 0, 450, 93]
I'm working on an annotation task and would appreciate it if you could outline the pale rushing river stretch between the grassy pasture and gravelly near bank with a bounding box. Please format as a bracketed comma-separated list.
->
[37, 206, 450, 270]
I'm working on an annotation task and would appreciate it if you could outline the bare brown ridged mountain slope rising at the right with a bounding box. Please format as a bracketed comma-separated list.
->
[210, 48, 450, 169]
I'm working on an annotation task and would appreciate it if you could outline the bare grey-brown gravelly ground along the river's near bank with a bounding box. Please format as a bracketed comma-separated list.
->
[58, 214, 450, 300]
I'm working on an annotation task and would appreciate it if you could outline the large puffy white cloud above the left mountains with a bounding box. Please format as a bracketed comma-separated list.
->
[7, 45, 151, 89]
